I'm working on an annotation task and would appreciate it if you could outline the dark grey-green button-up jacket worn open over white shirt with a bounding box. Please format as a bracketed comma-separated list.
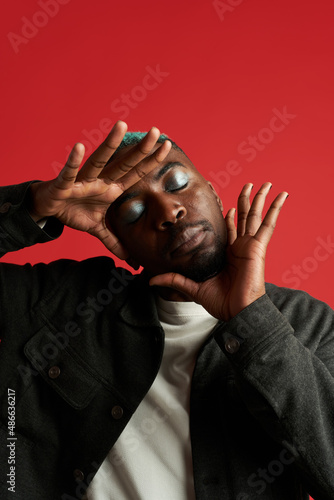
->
[0, 184, 334, 500]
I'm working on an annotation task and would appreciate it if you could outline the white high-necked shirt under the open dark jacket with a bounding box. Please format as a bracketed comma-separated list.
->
[86, 297, 217, 500]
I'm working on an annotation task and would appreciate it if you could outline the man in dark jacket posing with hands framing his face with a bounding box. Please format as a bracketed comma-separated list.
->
[0, 122, 334, 500]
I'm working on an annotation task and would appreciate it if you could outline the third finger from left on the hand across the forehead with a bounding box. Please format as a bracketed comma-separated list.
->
[101, 127, 160, 182]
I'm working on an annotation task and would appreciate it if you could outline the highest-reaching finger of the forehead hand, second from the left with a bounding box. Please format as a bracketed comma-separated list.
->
[78, 120, 128, 182]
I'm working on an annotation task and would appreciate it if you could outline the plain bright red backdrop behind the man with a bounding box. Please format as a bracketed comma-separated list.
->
[0, 0, 334, 494]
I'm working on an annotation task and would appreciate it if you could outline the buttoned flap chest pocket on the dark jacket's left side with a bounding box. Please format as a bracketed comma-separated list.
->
[24, 326, 99, 410]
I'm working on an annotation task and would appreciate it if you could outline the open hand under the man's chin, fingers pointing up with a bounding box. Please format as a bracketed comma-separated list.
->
[150, 183, 287, 321]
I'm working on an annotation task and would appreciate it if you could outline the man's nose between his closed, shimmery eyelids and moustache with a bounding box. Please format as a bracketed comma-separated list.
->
[152, 195, 187, 231]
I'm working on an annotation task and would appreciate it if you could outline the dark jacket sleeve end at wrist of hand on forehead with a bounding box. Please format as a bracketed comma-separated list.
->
[0, 182, 63, 256]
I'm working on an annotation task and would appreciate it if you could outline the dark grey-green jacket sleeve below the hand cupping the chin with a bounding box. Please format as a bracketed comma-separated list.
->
[215, 285, 334, 500]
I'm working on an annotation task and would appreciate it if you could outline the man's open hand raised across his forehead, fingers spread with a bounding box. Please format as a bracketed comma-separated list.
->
[29, 121, 171, 259]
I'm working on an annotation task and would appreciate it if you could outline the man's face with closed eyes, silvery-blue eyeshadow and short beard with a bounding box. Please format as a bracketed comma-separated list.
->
[107, 145, 227, 281]
